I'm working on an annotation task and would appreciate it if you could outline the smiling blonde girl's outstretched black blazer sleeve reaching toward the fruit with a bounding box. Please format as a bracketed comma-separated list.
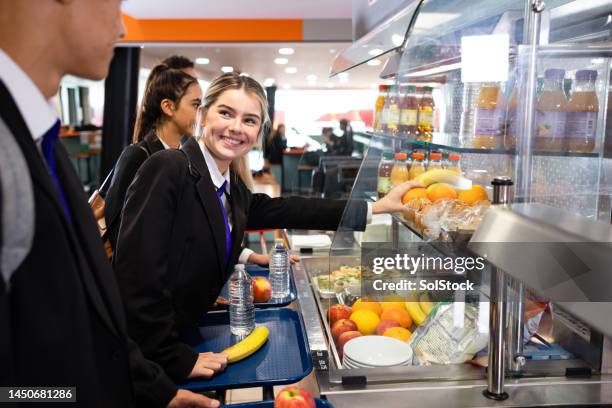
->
[247, 190, 368, 231]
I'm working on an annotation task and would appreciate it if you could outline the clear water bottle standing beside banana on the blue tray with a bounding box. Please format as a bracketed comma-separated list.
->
[229, 265, 255, 337]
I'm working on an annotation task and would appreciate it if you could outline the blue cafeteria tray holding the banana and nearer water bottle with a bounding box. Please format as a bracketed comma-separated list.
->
[181, 308, 312, 391]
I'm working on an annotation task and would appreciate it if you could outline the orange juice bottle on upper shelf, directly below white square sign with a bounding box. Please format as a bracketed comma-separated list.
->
[472, 83, 506, 149]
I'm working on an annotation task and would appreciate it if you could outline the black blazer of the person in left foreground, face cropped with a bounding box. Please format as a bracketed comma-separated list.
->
[0, 81, 176, 408]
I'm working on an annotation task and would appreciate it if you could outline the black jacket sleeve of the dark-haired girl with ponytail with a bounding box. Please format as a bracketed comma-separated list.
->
[104, 145, 147, 250]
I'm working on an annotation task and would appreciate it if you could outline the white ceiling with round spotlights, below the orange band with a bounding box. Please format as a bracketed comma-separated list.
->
[142, 43, 384, 89]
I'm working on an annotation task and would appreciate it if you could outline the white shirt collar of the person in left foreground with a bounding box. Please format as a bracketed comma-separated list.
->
[0, 49, 58, 142]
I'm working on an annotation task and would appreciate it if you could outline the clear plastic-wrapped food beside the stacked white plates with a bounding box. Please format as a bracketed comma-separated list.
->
[408, 303, 489, 365]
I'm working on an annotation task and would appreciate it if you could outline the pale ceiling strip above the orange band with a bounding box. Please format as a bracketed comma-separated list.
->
[122, 0, 352, 19]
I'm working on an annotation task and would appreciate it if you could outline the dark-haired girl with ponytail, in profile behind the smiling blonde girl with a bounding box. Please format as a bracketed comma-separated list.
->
[105, 64, 202, 250]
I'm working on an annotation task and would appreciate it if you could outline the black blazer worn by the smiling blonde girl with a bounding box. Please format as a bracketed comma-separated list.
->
[114, 138, 367, 382]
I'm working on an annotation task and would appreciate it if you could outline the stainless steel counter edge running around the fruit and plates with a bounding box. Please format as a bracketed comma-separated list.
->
[294, 233, 612, 408]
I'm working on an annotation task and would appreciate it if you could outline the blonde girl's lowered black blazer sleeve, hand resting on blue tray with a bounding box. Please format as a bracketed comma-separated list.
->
[114, 150, 198, 382]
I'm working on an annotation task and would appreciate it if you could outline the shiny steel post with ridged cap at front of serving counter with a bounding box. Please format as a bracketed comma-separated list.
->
[483, 177, 513, 400]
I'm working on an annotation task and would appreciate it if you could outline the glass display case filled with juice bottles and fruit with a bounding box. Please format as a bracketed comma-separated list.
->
[304, 0, 612, 398]
